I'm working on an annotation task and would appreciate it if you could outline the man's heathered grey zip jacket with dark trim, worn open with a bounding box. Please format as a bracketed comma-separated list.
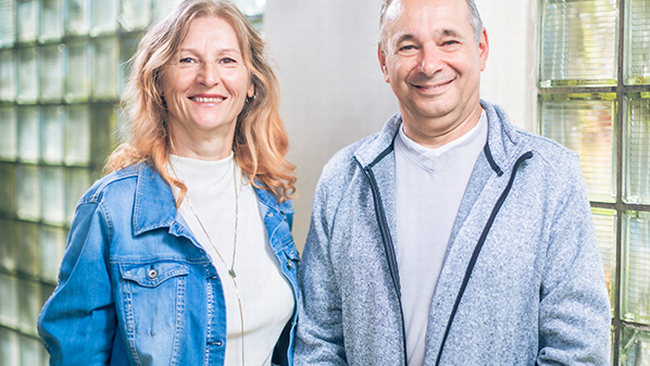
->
[295, 101, 611, 366]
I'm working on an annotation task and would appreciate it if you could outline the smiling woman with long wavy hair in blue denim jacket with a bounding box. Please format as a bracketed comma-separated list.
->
[38, 0, 298, 366]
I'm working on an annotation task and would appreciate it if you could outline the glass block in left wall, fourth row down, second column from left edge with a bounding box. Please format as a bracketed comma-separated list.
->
[16, 165, 41, 221]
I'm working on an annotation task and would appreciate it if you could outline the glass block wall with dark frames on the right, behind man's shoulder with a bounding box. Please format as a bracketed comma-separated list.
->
[538, 0, 650, 365]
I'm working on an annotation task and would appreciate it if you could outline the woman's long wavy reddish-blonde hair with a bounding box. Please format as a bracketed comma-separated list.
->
[105, 0, 296, 205]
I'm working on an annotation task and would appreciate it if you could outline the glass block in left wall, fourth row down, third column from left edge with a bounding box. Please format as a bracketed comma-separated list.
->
[40, 166, 65, 225]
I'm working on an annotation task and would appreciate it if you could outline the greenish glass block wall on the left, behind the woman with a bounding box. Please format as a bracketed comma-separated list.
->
[0, 0, 266, 366]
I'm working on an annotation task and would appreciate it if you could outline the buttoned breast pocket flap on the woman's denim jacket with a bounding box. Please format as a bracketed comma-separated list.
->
[120, 262, 190, 288]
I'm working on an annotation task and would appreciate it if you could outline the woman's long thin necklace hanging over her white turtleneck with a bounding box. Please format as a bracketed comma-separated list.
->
[169, 156, 245, 366]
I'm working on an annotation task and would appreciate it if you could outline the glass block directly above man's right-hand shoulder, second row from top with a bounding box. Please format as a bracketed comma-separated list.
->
[540, 94, 616, 202]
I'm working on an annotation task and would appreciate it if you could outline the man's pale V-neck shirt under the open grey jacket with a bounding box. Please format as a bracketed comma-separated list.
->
[395, 111, 488, 366]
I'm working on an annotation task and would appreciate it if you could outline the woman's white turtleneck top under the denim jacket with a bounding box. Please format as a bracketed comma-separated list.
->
[169, 154, 294, 366]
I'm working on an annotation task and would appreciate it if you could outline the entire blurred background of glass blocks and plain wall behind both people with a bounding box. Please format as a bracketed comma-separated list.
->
[0, 0, 650, 366]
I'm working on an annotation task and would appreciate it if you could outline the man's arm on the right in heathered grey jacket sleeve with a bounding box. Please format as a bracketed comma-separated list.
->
[537, 159, 611, 365]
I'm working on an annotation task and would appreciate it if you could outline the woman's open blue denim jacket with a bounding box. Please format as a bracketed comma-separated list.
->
[38, 164, 299, 365]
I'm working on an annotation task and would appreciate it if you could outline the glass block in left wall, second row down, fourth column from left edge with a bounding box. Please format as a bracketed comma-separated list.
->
[65, 42, 90, 102]
